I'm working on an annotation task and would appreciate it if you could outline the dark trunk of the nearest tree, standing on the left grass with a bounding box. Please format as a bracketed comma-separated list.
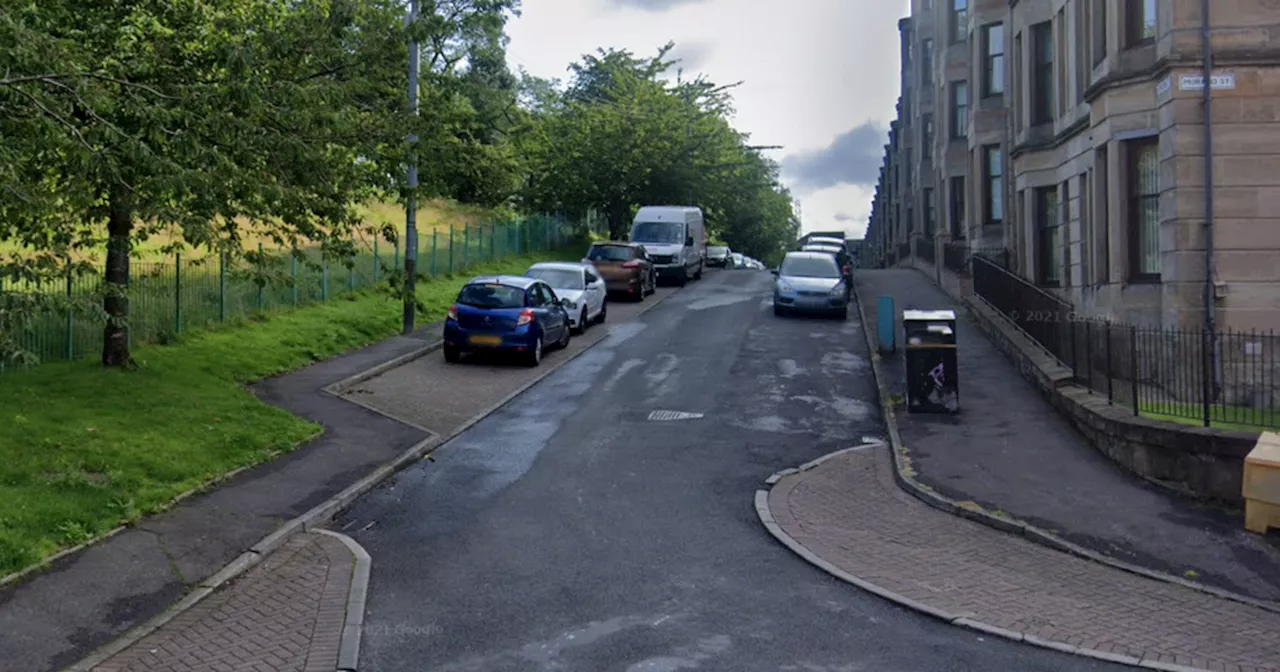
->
[102, 188, 133, 366]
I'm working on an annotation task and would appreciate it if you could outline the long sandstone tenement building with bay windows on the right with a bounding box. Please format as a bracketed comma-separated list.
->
[867, 0, 1280, 330]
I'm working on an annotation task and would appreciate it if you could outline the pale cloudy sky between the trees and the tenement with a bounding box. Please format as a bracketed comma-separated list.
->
[507, 0, 909, 238]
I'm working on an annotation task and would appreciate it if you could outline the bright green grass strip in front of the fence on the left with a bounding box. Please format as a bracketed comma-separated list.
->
[0, 243, 581, 576]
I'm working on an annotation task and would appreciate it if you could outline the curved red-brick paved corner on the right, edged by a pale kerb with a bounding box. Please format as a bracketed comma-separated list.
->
[768, 444, 1280, 672]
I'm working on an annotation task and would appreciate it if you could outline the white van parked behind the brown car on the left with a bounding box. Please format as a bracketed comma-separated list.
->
[631, 205, 707, 285]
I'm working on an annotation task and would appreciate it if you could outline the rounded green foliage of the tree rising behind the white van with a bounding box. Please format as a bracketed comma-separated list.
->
[521, 44, 794, 259]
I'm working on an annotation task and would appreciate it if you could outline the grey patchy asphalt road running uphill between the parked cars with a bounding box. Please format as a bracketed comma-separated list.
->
[334, 271, 1112, 672]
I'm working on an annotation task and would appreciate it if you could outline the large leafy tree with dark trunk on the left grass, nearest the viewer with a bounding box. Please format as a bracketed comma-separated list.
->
[0, 0, 407, 366]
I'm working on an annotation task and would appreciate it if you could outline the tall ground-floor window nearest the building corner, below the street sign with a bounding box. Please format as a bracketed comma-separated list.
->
[1126, 137, 1161, 282]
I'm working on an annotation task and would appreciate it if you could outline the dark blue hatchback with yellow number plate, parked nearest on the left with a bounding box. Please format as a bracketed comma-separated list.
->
[443, 275, 571, 366]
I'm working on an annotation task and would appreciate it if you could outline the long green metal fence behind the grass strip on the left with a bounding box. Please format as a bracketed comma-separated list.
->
[0, 215, 570, 372]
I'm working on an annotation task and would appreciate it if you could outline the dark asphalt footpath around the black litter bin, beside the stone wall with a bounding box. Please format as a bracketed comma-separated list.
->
[856, 269, 1280, 602]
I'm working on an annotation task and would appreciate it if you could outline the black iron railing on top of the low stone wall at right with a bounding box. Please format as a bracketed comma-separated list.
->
[972, 257, 1280, 429]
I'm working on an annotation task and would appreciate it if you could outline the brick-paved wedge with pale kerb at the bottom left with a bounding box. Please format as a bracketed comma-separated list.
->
[93, 534, 355, 672]
